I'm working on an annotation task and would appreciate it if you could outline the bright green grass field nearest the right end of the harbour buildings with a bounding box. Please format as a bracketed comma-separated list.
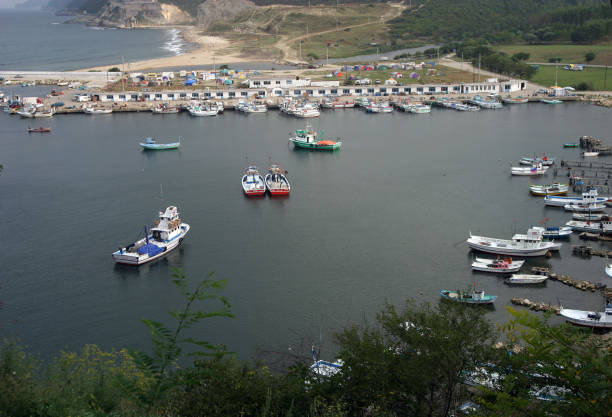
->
[530, 65, 612, 91]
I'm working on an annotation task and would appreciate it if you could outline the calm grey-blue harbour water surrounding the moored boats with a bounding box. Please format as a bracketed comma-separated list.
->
[0, 104, 612, 357]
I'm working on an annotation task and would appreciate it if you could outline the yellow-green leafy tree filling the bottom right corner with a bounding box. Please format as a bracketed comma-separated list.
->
[479, 308, 612, 417]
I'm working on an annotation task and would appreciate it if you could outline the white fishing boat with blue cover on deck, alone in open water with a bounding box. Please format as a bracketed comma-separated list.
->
[113, 206, 190, 265]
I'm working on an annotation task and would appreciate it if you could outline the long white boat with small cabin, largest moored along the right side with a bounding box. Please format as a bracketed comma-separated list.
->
[467, 228, 561, 257]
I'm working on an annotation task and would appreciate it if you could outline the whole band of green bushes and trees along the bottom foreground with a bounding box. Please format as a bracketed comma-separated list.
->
[0, 271, 612, 417]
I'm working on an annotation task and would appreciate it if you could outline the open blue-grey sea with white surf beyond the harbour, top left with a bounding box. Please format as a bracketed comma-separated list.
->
[0, 10, 190, 71]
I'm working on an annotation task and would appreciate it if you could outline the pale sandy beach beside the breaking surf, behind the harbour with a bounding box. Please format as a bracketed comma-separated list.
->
[75, 26, 262, 71]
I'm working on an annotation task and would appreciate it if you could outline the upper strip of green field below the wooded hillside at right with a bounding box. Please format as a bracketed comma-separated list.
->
[495, 43, 612, 65]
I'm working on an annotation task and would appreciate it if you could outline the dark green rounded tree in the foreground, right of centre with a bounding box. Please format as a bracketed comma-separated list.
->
[333, 301, 494, 416]
